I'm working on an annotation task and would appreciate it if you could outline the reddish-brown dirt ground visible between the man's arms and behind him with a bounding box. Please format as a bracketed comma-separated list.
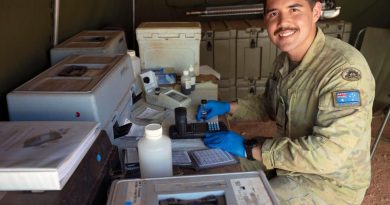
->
[230, 112, 390, 205]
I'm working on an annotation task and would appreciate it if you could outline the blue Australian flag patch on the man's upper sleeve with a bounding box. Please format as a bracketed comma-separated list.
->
[333, 90, 361, 107]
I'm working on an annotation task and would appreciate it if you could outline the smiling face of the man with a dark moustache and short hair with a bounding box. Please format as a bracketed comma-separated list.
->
[264, 0, 321, 60]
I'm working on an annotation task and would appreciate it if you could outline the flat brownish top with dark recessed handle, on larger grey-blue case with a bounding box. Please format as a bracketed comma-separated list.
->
[15, 55, 125, 94]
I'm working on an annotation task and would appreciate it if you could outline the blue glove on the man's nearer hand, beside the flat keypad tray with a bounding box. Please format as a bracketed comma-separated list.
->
[203, 131, 246, 158]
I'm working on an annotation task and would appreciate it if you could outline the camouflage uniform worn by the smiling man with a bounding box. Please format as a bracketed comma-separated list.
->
[232, 29, 375, 204]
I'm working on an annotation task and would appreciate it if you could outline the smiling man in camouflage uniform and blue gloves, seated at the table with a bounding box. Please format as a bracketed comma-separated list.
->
[197, 0, 375, 204]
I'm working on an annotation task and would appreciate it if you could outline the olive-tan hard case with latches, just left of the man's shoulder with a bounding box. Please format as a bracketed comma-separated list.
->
[227, 20, 277, 98]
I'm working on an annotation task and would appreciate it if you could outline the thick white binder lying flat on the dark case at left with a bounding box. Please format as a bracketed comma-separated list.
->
[0, 121, 100, 191]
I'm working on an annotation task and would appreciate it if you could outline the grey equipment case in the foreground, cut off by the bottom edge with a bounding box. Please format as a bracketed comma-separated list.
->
[107, 171, 277, 205]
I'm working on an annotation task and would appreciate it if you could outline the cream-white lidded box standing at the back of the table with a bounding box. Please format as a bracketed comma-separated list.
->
[136, 22, 201, 75]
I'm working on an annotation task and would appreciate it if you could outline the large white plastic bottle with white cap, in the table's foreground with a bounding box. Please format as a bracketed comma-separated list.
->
[138, 124, 173, 178]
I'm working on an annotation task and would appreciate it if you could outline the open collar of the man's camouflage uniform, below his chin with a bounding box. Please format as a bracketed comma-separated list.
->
[279, 27, 325, 76]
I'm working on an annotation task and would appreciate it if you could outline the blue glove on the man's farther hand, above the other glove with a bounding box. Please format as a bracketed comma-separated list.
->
[196, 100, 230, 121]
